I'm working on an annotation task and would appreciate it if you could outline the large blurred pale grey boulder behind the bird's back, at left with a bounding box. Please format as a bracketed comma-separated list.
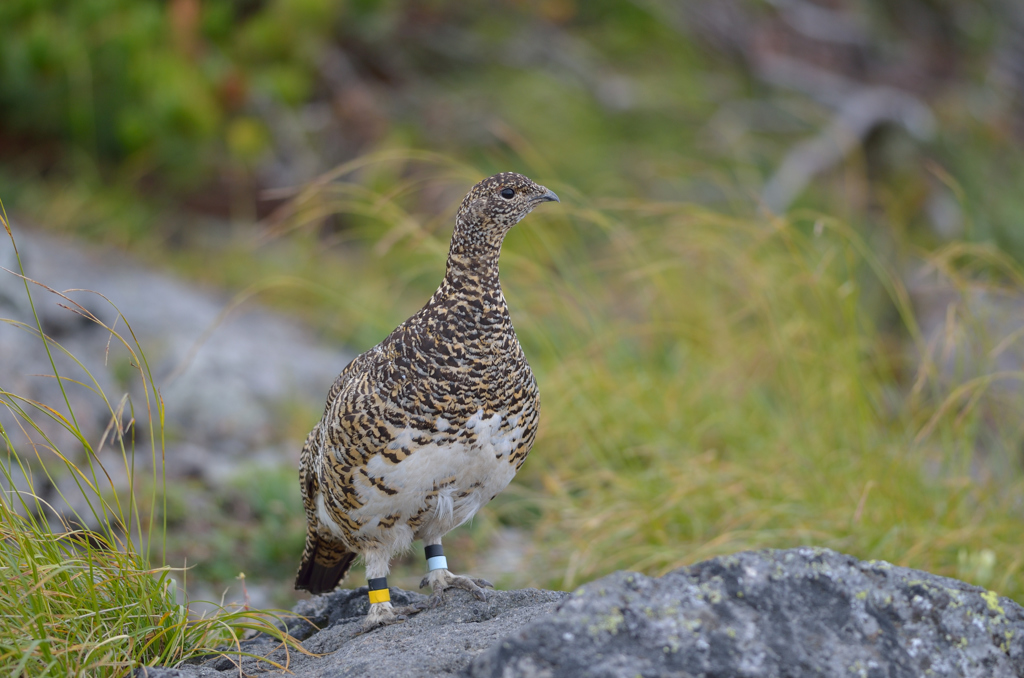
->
[0, 228, 352, 489]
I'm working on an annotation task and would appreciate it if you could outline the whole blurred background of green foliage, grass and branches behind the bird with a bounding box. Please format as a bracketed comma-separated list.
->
[0, 0, 1024, 602]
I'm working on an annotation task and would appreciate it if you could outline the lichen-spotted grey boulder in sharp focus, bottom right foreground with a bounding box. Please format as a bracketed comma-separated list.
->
[468, 548, 1024, 678]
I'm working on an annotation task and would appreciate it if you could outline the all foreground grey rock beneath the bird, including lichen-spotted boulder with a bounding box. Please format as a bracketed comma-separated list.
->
[138, 548, 1024, 678]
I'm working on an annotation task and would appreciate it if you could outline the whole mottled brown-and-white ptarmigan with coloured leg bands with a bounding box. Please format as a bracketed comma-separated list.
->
[295, 172, 558, 629]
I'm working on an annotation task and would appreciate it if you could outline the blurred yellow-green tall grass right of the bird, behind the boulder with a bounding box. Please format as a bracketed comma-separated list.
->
[512, 206, 1024, 599]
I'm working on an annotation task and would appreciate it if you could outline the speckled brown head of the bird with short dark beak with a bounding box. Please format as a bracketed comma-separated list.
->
[456, 172, 559, 246]
